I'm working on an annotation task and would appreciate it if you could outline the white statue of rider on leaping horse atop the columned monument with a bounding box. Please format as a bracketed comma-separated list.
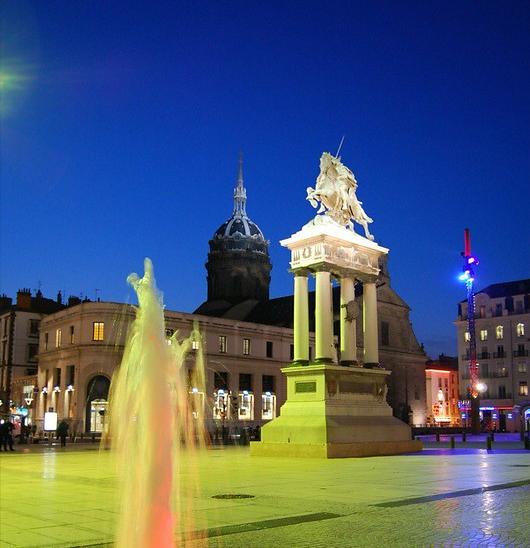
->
[306, 152, 374, 240]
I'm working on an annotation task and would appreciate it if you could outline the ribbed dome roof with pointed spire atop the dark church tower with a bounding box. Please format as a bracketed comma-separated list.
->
[212, 158, 268, 243]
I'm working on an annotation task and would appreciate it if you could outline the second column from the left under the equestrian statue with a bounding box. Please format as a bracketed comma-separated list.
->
[315, 270, 333, 363]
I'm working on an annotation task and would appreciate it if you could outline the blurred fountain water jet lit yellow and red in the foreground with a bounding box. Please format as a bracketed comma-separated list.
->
[107, 259, 205, 548]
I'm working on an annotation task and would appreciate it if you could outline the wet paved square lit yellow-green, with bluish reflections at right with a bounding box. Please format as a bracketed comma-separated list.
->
[0, 445, 530, 548]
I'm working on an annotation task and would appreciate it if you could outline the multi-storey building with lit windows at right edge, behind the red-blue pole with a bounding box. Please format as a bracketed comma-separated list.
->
[455, 279, 530, 431]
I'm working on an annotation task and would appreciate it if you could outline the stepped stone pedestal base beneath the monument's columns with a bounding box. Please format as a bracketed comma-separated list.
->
[250, 365, 422, 458]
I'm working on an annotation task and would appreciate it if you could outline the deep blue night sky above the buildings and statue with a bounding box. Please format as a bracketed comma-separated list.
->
[0, 0, 530, 355]
